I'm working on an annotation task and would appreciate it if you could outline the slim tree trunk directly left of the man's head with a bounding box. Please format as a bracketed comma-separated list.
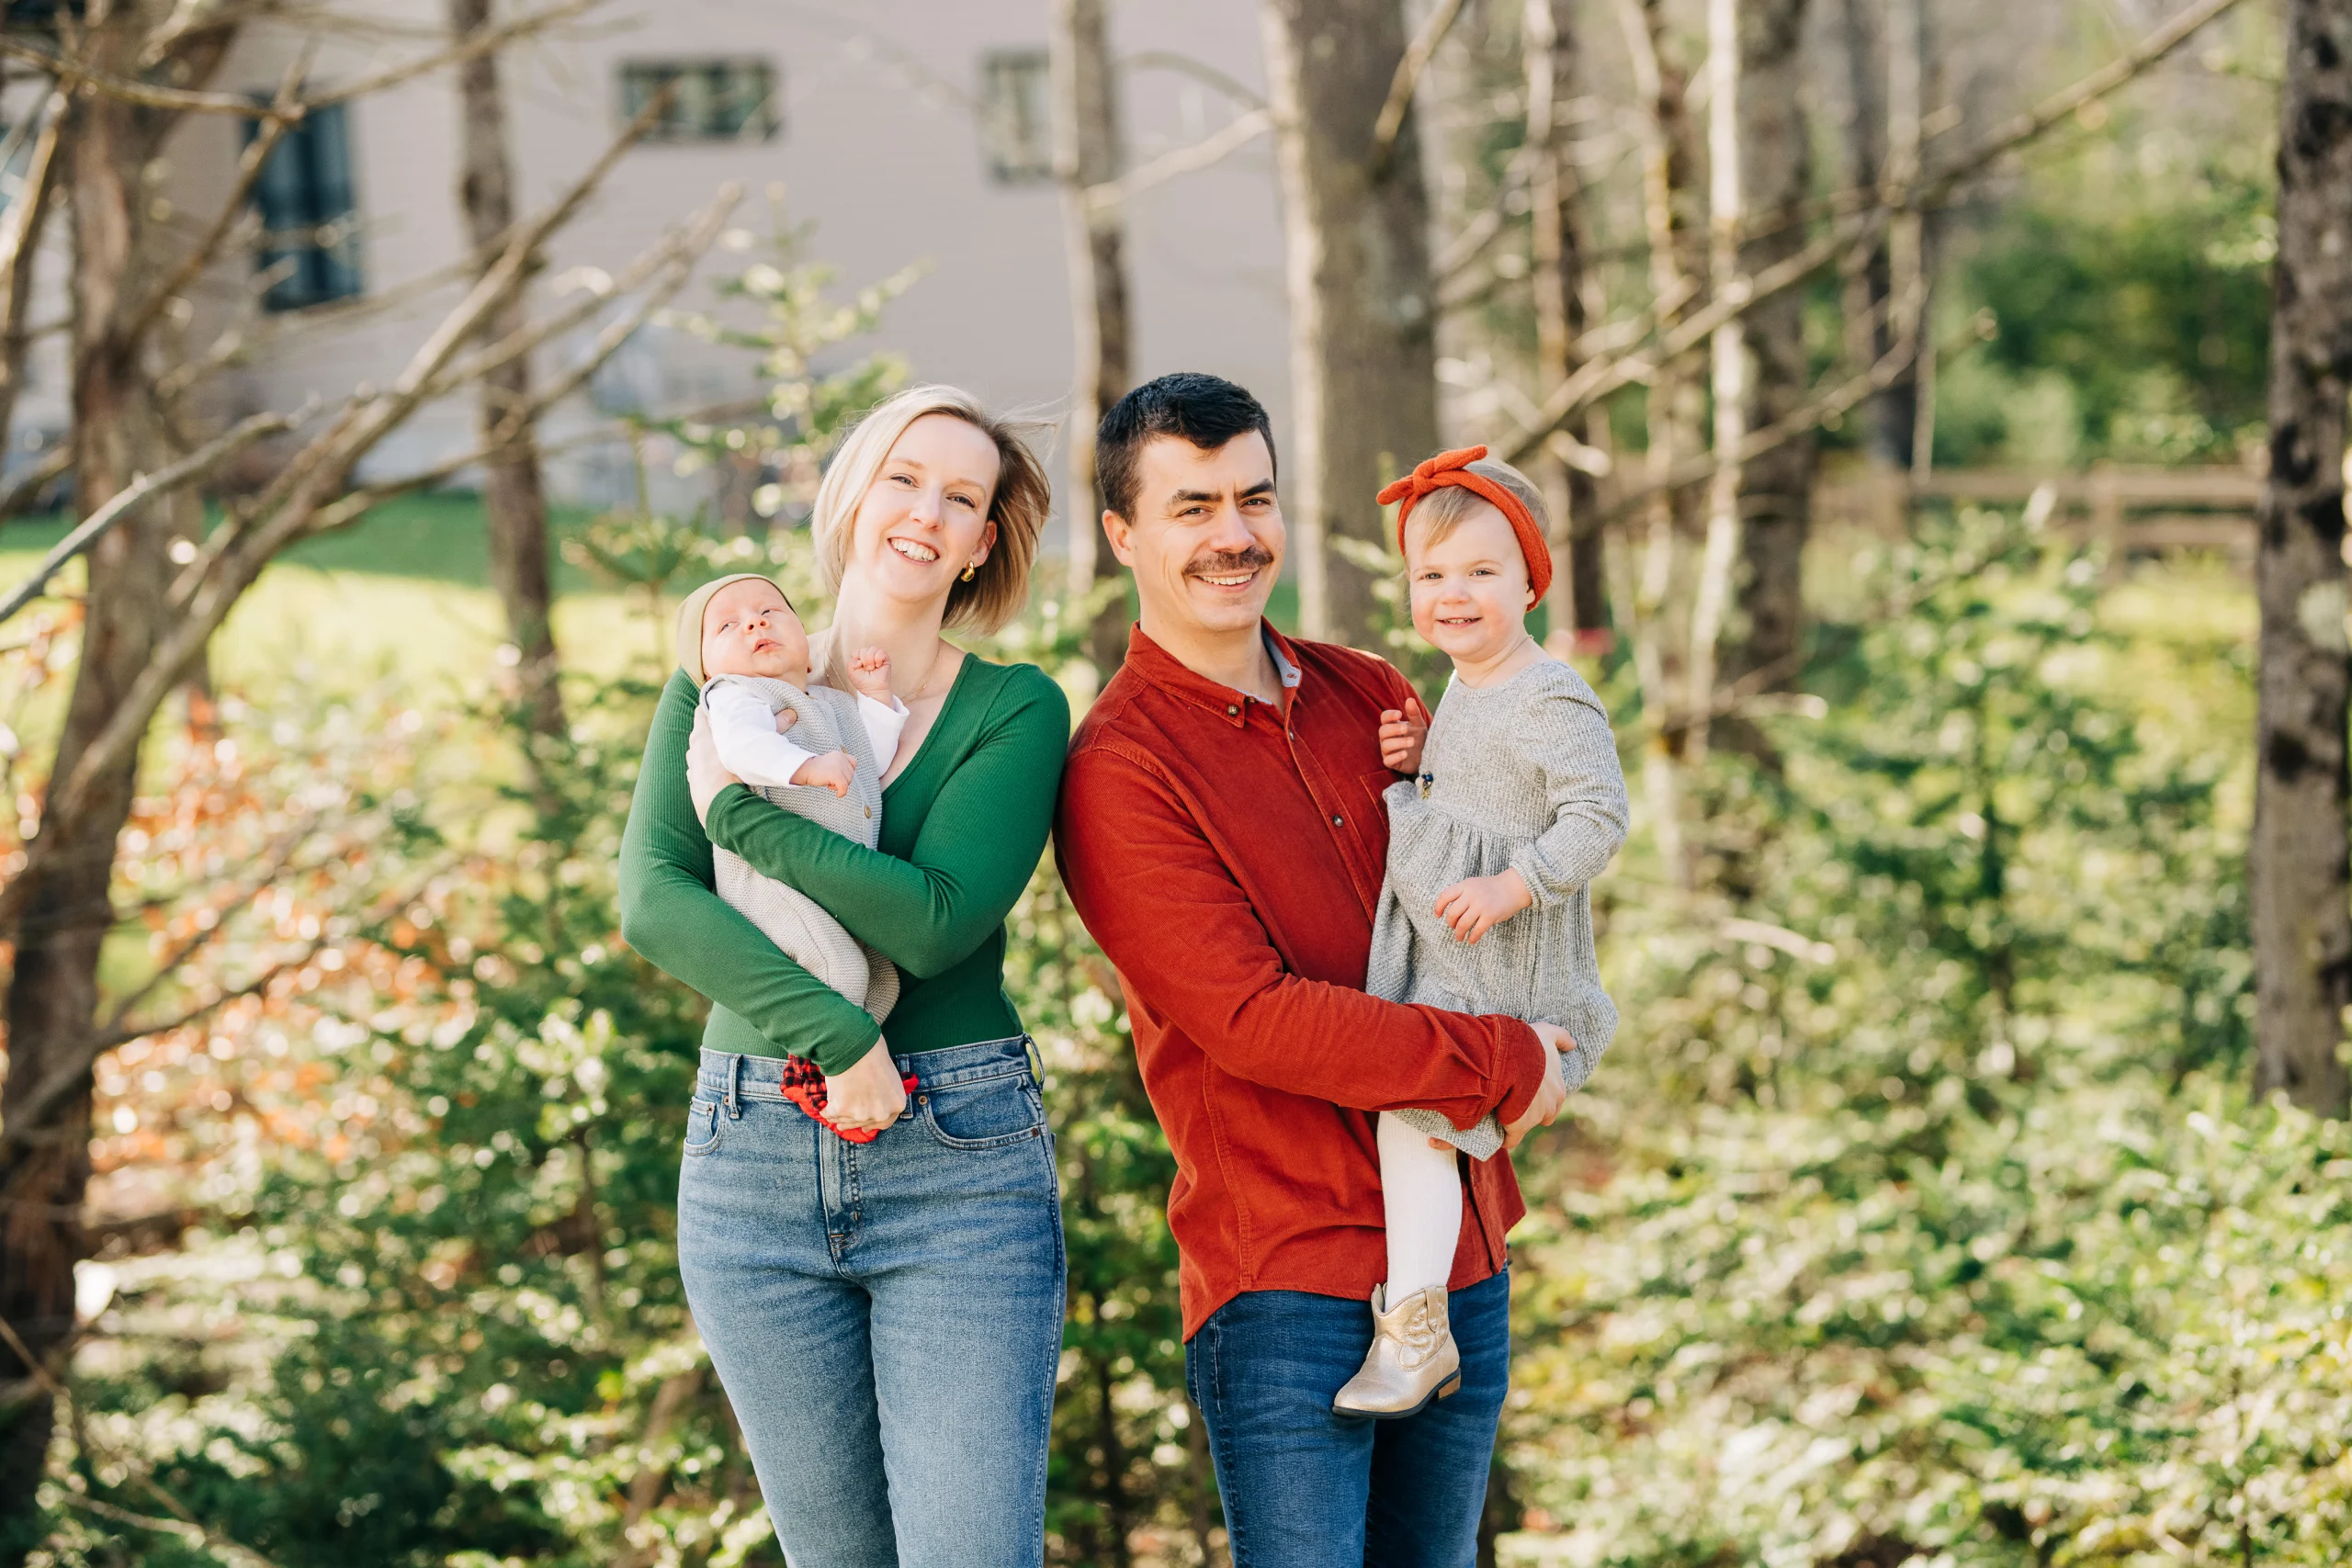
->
[1051, 0, 1134, 682]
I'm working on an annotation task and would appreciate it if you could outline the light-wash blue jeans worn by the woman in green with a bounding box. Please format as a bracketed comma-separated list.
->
[677, 1039, 1063, 1568]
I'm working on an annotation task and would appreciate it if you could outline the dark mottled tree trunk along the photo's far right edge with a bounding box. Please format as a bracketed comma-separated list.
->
[2248, 0, 2352, 1117]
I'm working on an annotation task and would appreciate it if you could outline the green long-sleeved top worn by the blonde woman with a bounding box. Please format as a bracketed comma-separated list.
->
[621, 656, 1070, 1072]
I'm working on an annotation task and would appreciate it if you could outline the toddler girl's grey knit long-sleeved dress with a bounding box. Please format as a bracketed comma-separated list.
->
[1364, 659, 1625, 1159]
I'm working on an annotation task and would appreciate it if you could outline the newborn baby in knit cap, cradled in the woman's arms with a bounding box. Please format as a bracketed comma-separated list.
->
[677, 573, 906, 1021]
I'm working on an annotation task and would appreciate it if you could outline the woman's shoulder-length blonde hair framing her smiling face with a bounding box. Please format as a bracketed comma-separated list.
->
[809, 386, 1054, 635]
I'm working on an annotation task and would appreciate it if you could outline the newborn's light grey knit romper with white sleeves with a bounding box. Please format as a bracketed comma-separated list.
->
[703, 674, 899, 1022]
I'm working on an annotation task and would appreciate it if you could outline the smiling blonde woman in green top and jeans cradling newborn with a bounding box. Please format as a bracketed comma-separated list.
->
[621, 386, 1070, 1568]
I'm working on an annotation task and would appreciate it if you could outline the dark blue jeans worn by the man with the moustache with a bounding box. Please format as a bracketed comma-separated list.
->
[1183, 1269, 1510, 1568]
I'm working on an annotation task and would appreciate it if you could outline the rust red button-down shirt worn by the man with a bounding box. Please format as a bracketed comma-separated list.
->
[1054, 627, 1545, 1340]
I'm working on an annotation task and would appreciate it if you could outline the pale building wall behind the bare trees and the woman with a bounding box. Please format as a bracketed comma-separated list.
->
[205, 0, 1289, 533]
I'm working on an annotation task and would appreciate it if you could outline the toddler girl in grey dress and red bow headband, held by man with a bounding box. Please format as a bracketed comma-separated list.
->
[1331, 446, 1625, 1417]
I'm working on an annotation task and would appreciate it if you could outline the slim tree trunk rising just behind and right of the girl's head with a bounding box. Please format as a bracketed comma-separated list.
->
[1521, 0, 1609, 651]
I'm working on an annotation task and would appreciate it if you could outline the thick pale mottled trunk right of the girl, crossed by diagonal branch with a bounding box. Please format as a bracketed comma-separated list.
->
[1724, 0, 1818, 695]
